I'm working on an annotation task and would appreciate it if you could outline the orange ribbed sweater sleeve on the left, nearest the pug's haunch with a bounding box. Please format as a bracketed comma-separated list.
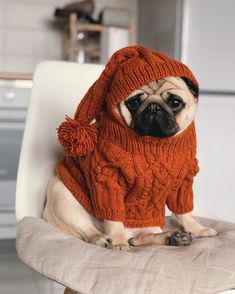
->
[91, 165, 126, 222]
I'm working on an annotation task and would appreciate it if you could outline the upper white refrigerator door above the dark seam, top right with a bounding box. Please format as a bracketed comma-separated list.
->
[181, 0, 235, 95]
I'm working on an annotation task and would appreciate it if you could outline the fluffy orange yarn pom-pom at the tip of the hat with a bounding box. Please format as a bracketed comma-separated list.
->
[58, 116, 97, 157]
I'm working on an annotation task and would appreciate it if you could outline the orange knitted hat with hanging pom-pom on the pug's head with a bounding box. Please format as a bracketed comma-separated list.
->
[58, 46, 198, 157]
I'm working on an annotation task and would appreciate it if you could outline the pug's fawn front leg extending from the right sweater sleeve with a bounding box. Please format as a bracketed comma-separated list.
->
[175, 212, 217, 237]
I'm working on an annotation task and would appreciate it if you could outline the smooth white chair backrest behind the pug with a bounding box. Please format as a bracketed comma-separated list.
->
[16, 61, 103, 221]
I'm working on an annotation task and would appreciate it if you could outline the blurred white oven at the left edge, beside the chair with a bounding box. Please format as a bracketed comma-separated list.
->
[0, 80, 32, 239]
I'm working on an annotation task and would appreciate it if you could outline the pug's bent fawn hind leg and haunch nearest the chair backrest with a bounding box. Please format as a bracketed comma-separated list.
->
[43, 177, 110, 247]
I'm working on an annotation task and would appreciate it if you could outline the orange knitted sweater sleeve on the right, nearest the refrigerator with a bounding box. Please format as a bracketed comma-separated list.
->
[166, 160, 199, 214]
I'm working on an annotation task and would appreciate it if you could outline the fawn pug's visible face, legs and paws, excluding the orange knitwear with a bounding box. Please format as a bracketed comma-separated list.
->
[43, 77, 217, 250]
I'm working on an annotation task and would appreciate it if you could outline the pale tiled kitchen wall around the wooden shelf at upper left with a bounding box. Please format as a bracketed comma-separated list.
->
[0, 0, 137, 73]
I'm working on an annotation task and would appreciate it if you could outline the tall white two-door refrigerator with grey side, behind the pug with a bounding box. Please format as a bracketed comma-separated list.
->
[139, 0, 235, 222]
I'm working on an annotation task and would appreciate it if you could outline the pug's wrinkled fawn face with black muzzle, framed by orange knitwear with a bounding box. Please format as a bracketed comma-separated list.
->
[117, 77, 198, 138]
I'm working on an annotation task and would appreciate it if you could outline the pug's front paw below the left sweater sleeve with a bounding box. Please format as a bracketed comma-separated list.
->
[104, 220, 130, 250]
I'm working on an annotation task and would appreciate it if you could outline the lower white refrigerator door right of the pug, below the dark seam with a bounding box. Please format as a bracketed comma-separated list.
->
[194, 95, 235, 222]
